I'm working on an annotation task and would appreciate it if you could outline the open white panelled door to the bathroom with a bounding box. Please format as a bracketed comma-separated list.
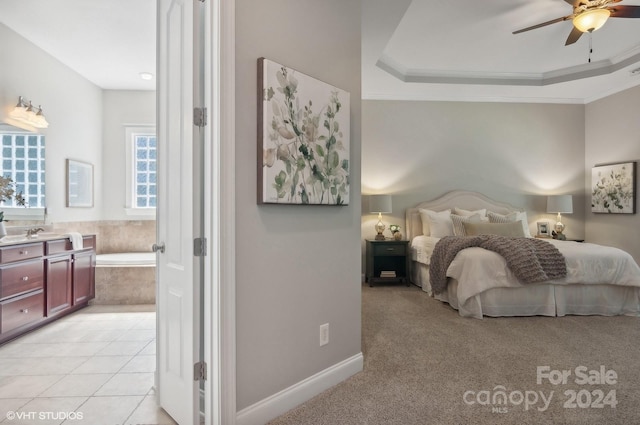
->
[156, 0, 201, 425]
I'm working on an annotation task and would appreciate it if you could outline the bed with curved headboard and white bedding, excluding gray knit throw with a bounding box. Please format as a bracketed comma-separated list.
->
[406, 191, 640, 318]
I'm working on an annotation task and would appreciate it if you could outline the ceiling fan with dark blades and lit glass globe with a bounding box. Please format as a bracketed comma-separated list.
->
[513, 0, 640, 46]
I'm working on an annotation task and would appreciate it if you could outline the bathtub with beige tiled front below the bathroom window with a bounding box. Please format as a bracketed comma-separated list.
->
[93, 252, 156, 304]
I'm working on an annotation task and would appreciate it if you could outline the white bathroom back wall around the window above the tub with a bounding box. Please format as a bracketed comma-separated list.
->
[102, 90, 156, 220]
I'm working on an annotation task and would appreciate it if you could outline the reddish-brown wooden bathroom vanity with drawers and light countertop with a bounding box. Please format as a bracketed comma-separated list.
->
[0, 235, 96, 344]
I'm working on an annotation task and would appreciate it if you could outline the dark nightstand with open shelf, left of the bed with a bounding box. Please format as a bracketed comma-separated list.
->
[366, 239, 410, 286]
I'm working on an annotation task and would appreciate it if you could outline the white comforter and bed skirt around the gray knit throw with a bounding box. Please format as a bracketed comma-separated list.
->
[412, 236, 640, 317]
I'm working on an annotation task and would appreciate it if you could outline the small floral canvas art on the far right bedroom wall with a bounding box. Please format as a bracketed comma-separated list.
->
[591, 162, 636, 214]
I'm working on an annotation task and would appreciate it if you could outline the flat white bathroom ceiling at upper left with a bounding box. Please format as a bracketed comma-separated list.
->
[0, 0, 156, 90]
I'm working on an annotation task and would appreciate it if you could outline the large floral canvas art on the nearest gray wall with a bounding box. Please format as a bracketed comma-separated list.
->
[258, 58, 351, 205]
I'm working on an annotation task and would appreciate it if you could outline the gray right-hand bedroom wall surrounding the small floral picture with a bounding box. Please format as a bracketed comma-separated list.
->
[584, 86, 640, 262]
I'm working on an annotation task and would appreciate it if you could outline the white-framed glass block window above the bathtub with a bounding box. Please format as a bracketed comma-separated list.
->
[126, 127, 158, 215]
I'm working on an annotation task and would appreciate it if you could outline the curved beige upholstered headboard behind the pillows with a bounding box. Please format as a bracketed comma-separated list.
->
[406, 190, 524, 240]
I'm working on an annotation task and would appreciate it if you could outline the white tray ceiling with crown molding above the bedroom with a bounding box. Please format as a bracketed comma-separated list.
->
[362, 0, 640, 103]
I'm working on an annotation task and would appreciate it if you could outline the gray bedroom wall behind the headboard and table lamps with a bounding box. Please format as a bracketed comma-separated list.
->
[362, 100, 585, 243]
